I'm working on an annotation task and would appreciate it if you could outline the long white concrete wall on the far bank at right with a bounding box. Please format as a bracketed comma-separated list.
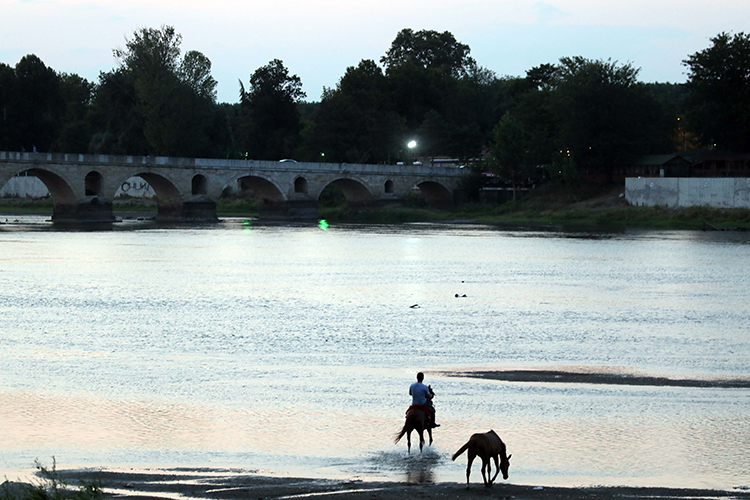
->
[625, 177, 750, 208]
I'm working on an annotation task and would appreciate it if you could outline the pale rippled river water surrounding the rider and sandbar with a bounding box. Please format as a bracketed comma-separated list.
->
[0, 217, 750, 489]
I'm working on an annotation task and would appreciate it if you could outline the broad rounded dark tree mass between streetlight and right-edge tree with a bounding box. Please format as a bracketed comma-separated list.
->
[493, 57, 672, 183]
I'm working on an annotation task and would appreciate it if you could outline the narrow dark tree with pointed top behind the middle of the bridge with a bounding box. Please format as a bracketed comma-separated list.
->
[238, 59, 305, 160]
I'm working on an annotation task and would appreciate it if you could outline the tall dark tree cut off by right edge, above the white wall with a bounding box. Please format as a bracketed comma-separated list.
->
[683, 33, 750, 151]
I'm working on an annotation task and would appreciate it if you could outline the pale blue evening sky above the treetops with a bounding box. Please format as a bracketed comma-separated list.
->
[0, 0, 750, 103]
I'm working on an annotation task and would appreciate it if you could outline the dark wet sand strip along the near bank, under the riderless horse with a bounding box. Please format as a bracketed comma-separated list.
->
[41, 469, 750, 500]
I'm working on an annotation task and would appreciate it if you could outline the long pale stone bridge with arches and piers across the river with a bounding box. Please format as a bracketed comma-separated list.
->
[0, 151, 463, 222]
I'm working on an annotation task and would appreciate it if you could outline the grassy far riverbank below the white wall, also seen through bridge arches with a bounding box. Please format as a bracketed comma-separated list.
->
[0, 186, 750, 231]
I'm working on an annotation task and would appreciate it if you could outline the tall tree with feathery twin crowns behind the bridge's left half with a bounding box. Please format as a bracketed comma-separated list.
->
[97, 26, 222, 156]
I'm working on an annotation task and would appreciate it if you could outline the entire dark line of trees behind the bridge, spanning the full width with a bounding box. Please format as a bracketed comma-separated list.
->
[0, 26, 750, 182]
